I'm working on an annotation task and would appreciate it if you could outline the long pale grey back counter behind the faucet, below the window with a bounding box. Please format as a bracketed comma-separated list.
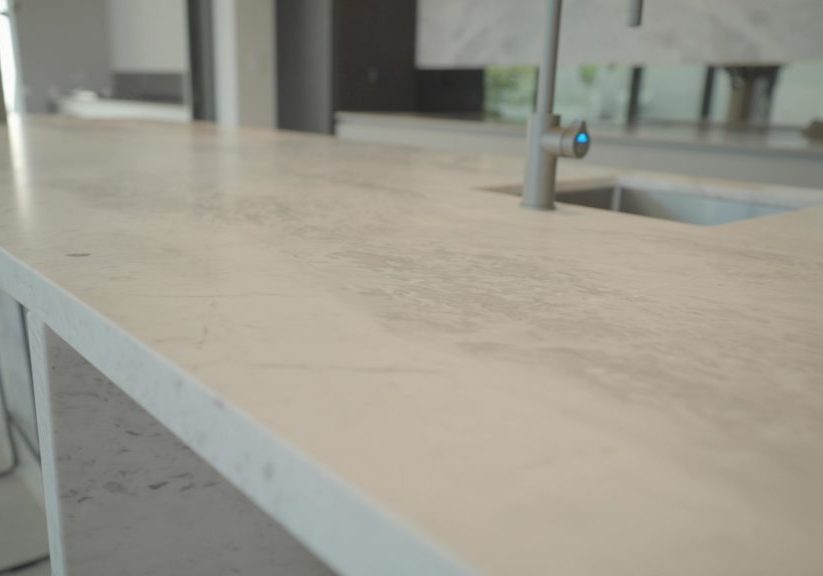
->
[336, 112, 823, 160]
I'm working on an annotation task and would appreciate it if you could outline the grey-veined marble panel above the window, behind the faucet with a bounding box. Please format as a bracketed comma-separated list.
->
[417, 0, 823, 68]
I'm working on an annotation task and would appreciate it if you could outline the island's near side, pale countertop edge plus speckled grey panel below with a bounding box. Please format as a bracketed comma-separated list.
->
[0, 250, 464, 576]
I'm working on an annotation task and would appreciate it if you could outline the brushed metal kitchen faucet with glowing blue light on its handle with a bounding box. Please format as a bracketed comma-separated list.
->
[523, 0, 643, 210]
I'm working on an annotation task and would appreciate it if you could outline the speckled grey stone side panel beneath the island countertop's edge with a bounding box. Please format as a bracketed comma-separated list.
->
[31, 324, 332, 576]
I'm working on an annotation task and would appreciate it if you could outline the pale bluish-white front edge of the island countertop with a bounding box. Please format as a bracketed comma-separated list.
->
[0, 248, 473, 576]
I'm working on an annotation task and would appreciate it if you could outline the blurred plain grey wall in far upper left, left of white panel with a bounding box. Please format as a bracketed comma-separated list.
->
[16, 0, 112, 114]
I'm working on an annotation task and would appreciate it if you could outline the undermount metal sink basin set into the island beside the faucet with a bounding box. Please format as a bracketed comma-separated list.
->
[486, 178, 823, 226]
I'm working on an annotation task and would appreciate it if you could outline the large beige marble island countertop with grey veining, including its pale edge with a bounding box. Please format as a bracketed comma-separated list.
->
[0, 119, 823, 576]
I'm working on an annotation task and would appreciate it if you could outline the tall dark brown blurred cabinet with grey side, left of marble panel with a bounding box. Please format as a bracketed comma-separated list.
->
[275, 0, 417, 133]
